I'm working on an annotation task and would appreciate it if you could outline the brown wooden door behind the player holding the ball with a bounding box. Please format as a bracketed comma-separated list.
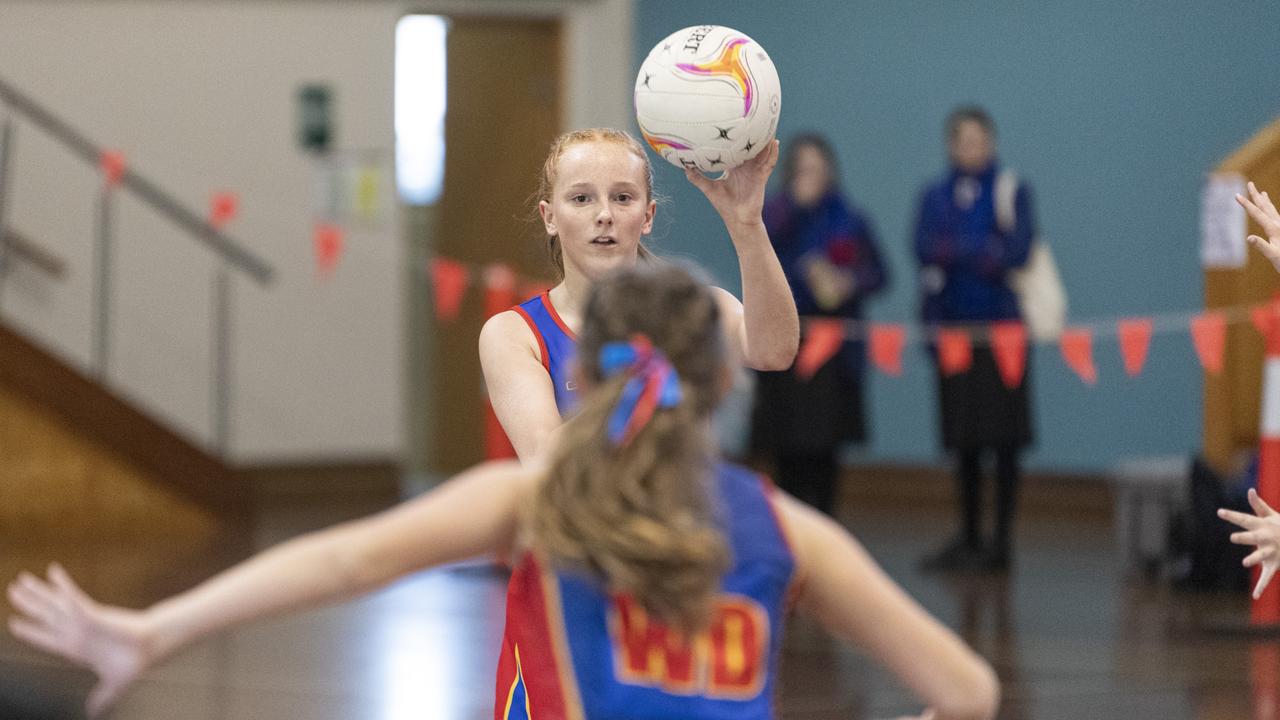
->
[429, 18, 561, 471]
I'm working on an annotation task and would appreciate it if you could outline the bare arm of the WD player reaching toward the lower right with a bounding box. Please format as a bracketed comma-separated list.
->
[776, 492, 1000, 720]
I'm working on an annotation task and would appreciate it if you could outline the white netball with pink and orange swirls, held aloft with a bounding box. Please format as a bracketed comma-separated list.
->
[635, 26, 782, 173]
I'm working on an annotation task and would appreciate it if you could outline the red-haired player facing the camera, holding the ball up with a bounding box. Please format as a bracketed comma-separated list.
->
[480, 128, 800, 461]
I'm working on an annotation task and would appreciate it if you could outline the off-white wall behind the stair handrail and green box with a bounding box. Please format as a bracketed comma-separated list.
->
[0, 0, 632, 462]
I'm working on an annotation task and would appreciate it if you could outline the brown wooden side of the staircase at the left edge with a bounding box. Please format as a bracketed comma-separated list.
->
[0, 323, 252, 541]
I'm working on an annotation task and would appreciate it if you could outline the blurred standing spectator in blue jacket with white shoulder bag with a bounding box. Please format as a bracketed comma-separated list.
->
[915, 108, 1036, 571]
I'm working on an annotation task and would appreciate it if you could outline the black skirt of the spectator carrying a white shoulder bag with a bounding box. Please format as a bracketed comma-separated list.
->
[934, 346, 1033, 450]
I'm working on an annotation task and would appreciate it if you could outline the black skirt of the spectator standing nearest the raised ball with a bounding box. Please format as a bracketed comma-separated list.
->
[751, 342, 867, 456]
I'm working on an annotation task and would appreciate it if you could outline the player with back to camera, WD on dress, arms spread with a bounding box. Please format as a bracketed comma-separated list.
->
[9, 265, 998, 720]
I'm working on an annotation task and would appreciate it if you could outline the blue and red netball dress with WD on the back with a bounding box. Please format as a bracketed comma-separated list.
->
[494, 464, 795, 720]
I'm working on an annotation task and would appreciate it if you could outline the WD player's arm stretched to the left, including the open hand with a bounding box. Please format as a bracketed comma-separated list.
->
[9, 464, 534, 715]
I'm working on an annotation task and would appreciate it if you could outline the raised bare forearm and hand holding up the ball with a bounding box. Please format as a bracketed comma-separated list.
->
[685, 140, 800, 370]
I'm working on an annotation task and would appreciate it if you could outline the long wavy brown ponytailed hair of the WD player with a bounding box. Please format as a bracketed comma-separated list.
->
[534, 265, 730, 633]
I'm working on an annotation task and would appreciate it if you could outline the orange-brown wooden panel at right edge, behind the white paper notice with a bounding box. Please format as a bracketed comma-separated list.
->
[1203, 120, 1280, 469]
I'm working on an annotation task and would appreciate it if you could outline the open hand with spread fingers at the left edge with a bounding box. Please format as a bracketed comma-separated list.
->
[9, 562, 148, 717]
